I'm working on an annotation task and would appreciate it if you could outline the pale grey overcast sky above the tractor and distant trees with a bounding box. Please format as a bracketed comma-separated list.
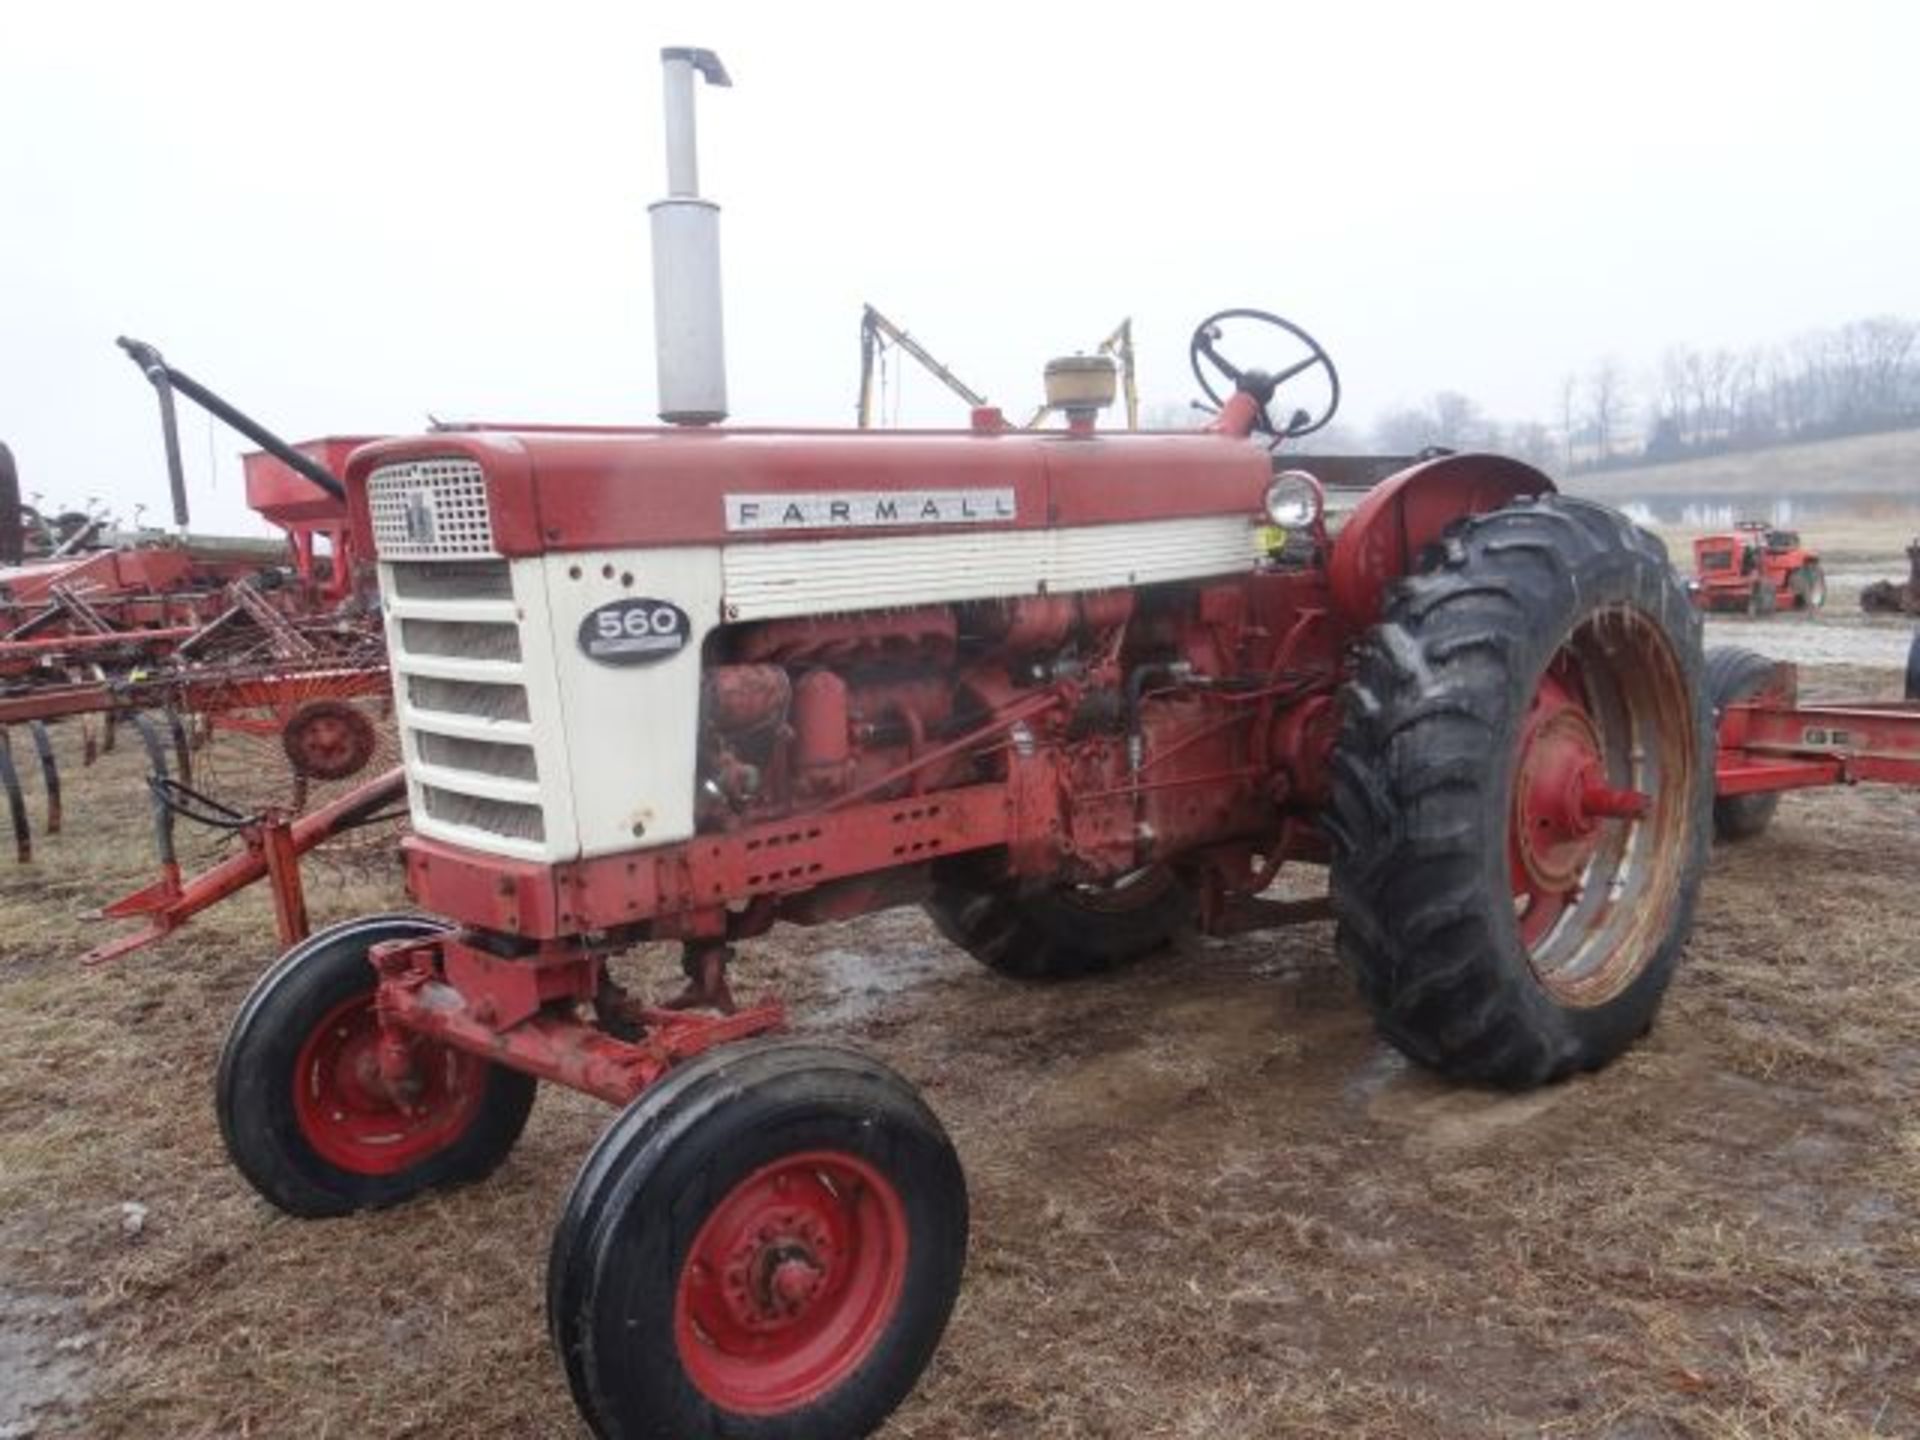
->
[0, 0, 1920, 530]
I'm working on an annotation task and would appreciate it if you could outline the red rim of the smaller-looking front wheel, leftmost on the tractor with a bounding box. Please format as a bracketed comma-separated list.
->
[294, 995, 486, 1175]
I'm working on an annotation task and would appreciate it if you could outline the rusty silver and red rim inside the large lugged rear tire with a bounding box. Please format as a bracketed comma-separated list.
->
[1507, 609, 1701, 1008]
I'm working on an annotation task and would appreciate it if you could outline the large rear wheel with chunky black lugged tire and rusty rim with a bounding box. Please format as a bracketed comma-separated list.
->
[1329, 495, 1713, 1089]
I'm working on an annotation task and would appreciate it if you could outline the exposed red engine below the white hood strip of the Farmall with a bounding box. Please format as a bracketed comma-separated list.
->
[697, 586, 1275, 881]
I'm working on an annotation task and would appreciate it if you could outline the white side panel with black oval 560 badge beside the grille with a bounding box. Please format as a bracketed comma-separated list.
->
[528, 547, 720, 856]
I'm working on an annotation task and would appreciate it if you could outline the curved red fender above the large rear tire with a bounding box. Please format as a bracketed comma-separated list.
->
[1327, 455, 1553, 626]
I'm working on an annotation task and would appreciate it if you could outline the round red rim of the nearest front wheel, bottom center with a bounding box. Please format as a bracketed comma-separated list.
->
[674, 1150, 908, 1415]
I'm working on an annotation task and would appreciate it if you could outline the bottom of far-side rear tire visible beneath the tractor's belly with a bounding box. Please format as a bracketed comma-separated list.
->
[925, 866, 1194, 981]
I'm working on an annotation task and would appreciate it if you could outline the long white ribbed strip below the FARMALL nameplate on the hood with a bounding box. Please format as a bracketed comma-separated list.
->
[721, 515, 1260, 620]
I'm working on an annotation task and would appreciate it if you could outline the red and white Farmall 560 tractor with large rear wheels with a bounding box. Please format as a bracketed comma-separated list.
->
[217, 52, 1715, 1436]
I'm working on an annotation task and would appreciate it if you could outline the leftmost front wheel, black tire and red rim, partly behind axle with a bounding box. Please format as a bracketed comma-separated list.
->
[213, 914, 536, 1219]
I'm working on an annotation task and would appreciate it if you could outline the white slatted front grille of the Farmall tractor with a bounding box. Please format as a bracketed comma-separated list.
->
[376, 545, 547, 858]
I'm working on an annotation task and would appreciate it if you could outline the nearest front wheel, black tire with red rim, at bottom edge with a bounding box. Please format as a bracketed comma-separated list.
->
[547, 1043, 968, 1440]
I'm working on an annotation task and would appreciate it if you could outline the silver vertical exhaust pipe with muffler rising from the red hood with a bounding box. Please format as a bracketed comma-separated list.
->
[647, 46, 733, 424]
